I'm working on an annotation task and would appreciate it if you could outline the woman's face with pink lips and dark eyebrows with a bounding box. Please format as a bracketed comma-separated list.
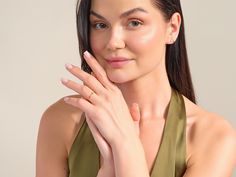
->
[90, 0, 171, 83]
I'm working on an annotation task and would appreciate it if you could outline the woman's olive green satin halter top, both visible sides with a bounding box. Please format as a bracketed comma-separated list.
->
[68, 90, 186, 177]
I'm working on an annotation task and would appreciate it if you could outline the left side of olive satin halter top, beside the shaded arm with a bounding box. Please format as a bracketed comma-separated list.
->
[68, 113, 100, 177]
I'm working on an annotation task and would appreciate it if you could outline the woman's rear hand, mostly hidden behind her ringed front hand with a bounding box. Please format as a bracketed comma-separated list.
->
[86, 103, 140, 177]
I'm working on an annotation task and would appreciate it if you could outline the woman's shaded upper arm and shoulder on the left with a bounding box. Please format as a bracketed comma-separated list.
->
[36, 97, 84, 177]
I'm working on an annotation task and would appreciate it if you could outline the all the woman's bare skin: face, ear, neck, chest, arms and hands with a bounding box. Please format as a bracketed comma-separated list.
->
[36, 0, 236, 177]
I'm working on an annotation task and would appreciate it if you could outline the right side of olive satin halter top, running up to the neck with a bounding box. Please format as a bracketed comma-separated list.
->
[151, 90, 186, 177]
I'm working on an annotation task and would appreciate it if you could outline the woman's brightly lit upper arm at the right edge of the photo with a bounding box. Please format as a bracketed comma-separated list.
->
[184, 114, 236, 177]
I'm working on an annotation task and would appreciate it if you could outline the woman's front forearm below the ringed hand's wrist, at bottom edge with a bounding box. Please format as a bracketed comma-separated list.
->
[112, 138, 150, 177]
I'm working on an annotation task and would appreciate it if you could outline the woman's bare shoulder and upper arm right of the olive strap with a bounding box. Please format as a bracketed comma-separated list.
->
[184, 98, 236, 176]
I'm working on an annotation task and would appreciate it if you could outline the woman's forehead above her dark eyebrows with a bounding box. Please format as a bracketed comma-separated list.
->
[91, 0, 156, 13]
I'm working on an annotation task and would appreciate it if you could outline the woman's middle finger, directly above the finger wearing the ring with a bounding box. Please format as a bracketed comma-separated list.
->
[65, 64, 105, 94]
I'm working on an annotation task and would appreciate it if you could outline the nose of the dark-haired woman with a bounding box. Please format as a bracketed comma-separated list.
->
[107, 27, 125, 50]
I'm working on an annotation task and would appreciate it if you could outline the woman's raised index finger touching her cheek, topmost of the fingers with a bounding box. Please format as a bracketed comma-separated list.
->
[84, 51, 114, 89]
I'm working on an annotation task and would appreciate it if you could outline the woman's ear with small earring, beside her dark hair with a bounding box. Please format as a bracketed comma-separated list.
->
[166, 12, 181, 44]
